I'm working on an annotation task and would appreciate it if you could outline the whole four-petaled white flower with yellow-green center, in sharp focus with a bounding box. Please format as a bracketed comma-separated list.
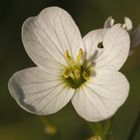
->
[8, 7, 130, 122]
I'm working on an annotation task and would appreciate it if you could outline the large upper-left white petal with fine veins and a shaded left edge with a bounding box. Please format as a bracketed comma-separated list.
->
[22, 7, 83, 69]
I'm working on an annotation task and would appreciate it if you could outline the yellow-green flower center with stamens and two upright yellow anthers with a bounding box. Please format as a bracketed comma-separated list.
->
[63, 49, 92, 89]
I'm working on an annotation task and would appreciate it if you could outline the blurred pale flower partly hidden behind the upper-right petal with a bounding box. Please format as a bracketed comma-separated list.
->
[104, 17, 140, 55]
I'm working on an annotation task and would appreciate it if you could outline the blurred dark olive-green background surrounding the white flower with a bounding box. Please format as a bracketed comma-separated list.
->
[0, 0, 140, 140]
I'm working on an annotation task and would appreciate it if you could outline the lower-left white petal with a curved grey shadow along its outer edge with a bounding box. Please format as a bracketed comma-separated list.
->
[8, 67, 74, 115]
